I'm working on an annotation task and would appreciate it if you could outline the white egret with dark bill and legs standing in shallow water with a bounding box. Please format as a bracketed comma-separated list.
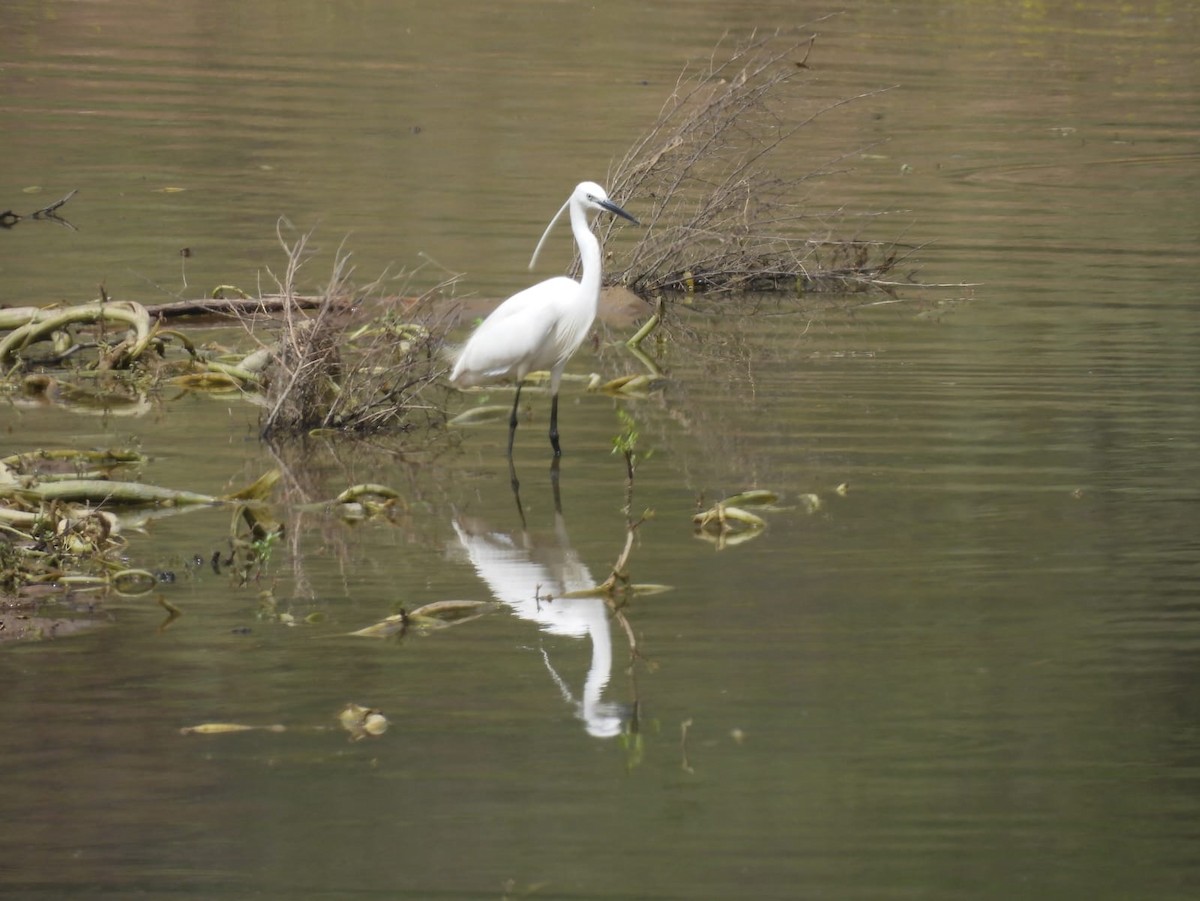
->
[450, 181, 641, 459]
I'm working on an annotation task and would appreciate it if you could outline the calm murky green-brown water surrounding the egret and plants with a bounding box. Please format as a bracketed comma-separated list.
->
[0, 0, 1200, 899]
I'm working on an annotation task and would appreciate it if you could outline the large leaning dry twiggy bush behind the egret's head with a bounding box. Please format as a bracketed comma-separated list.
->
[604, 31, 911, 298]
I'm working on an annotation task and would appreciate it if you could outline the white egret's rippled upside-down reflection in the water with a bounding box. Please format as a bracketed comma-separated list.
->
[451, 504, 626, 738]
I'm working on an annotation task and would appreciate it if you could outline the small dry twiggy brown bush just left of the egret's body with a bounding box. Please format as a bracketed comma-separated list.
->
[255, 222, 456, 437]
